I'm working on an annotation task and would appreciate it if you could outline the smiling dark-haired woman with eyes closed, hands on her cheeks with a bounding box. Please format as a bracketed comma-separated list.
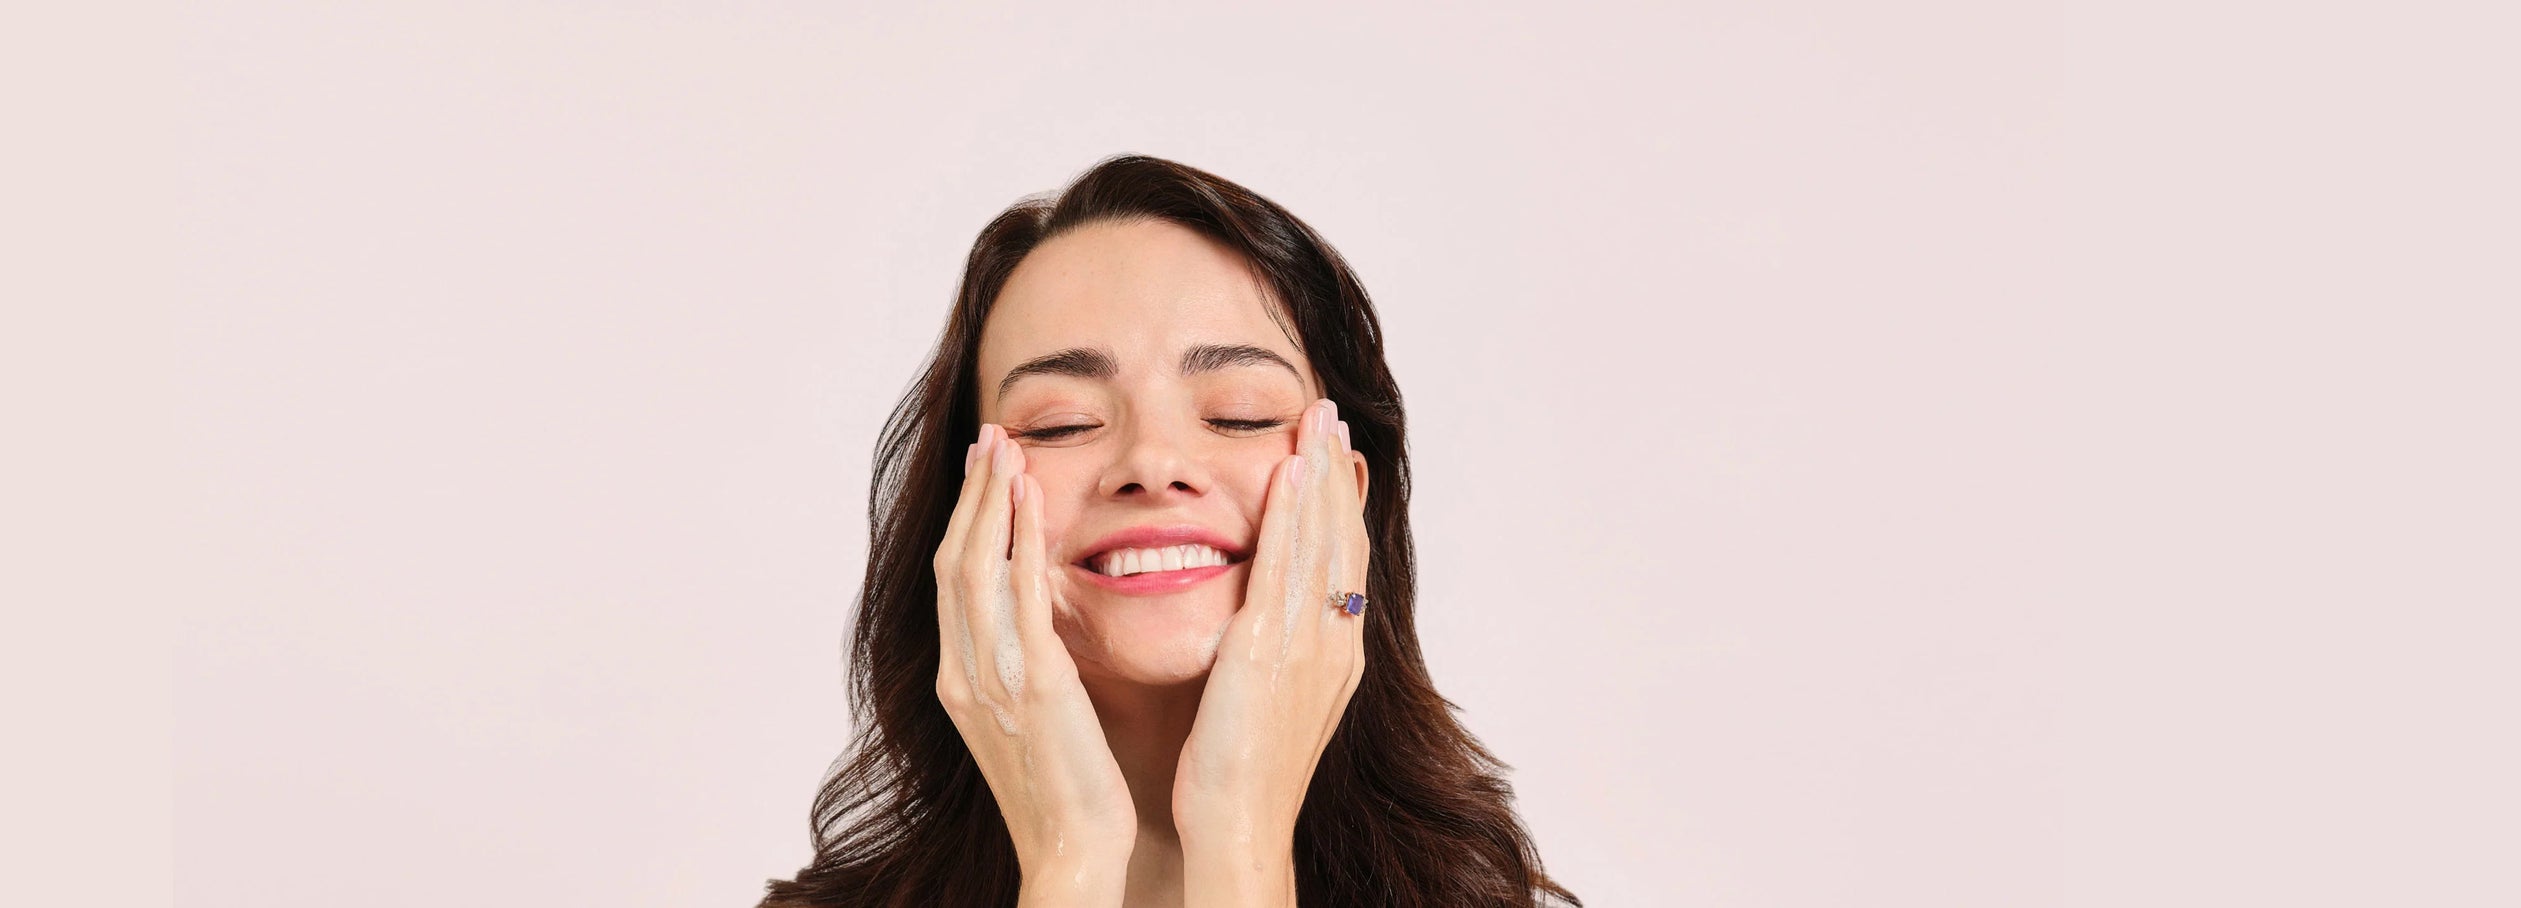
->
[761, 156, 1573, 908]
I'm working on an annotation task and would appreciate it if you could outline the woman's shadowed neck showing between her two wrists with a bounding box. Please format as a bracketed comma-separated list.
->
[1087, 676, 1208, 908]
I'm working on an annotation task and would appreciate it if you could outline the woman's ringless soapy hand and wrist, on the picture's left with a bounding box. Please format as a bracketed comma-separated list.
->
[935, 426, 1137, 905]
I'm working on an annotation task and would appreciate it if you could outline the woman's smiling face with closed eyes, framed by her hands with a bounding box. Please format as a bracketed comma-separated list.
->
[978, 219, 1321, 686]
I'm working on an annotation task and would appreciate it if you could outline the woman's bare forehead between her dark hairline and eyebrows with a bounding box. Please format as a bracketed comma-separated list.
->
[978, 219, 1313, 396]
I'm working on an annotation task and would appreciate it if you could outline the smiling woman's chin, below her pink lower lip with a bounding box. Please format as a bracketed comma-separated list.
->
[1059, 583, 1243, 686]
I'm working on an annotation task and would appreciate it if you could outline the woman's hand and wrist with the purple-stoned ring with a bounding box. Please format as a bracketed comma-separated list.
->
[1172, 399, 1371, 905]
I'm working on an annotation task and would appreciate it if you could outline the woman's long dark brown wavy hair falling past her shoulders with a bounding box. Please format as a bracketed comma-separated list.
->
[761, 154, 1581, 908]
